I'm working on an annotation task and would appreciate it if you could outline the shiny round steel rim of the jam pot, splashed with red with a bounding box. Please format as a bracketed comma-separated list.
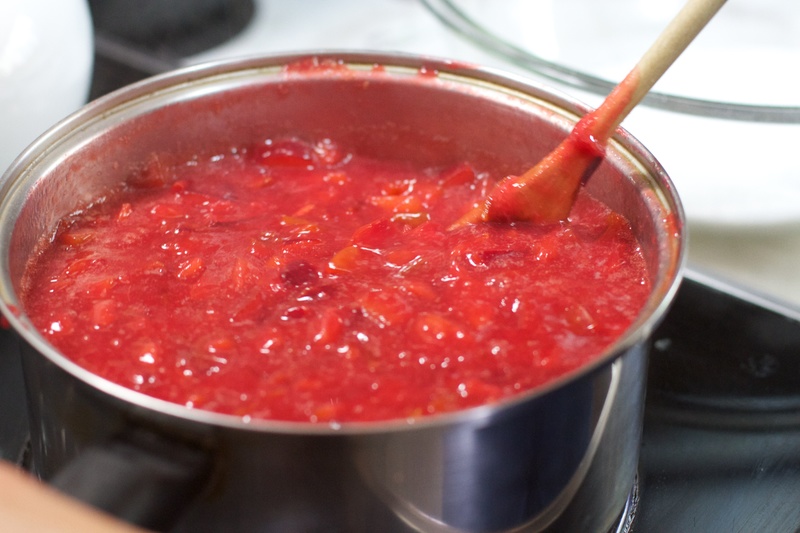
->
[0, 50, 687, 435]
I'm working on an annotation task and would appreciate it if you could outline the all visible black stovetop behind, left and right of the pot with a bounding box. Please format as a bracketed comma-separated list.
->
[0, 0, 800, 533]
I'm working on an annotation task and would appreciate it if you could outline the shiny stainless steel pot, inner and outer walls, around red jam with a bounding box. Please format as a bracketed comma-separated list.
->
[0, 53, 684, 532]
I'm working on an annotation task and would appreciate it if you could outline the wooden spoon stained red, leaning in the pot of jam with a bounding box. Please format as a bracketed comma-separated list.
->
[452, 0, 725, 228]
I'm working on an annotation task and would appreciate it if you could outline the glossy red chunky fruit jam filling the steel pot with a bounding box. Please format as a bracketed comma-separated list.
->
[23, 139, 650, 423]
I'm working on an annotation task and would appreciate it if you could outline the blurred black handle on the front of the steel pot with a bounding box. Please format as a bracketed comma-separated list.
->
[49, 429, 211, 531]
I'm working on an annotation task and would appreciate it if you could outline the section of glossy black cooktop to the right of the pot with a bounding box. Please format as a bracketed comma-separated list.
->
[634, 272, 800, 533]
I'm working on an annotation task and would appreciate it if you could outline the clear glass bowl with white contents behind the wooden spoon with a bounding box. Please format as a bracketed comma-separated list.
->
[423, 0, 800, 227]
